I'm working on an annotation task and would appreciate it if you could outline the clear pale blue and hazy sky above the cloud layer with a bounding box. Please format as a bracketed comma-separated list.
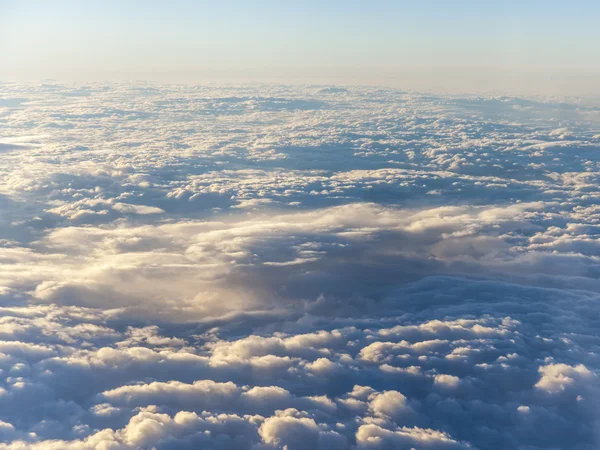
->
[0, 0, 600, 94]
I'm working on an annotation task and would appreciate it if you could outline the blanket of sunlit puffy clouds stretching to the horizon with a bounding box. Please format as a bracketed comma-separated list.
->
[0, 83, 600, 450]
